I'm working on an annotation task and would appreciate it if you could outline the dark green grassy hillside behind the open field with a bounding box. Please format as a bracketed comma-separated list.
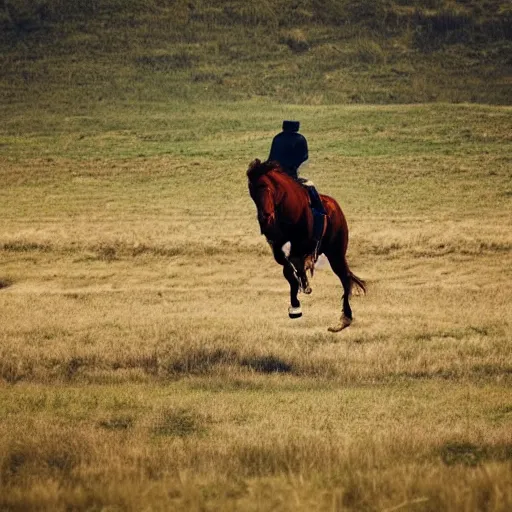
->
[0, 0, 512, 107]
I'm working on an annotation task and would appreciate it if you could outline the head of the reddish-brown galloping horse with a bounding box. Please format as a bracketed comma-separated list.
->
[247, 159, 278, 239]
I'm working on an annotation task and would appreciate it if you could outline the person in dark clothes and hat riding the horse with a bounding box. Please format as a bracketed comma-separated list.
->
[268, 121, 326, 260]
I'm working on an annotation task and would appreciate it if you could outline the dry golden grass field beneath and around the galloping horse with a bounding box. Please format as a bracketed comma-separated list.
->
[0, 100, 512, 512]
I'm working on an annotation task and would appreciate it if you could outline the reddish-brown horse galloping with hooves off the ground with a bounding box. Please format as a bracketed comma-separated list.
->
[247, 159, 366, 332]
